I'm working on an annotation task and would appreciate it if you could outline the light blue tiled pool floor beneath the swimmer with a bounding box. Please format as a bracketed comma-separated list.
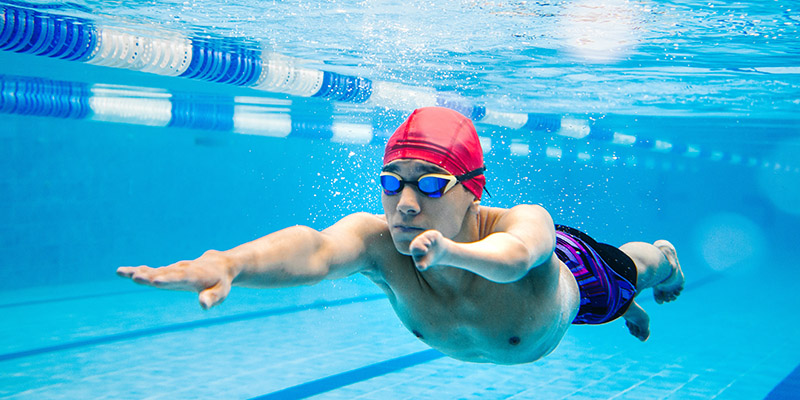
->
[0, 266, 800, 400]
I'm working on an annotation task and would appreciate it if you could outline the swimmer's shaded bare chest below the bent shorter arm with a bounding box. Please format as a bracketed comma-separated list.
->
[368, 261, 566, 364]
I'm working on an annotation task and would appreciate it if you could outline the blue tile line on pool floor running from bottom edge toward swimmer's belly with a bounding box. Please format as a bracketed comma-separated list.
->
[250, 350, 444, 400]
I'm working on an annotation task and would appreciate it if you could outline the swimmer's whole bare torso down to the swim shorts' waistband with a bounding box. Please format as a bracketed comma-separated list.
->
[364, 207, 579, 364]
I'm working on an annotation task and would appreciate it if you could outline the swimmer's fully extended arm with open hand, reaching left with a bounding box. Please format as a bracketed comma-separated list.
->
[117, 213, 388, 309]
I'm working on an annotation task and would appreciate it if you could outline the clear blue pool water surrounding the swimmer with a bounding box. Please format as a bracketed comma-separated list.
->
[0, 1, 800, 399]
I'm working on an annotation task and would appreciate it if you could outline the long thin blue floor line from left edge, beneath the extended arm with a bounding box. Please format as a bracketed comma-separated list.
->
[0, 294, 386, 362]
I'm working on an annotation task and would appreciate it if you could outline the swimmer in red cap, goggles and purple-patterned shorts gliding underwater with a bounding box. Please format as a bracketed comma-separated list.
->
[117, 107, 684, 364]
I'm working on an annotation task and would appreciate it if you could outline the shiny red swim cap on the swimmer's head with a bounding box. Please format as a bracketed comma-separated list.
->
[383, 107, 486, 200]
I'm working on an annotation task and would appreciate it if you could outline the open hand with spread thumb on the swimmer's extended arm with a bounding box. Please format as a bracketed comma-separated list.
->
[117, 250, 235, 310]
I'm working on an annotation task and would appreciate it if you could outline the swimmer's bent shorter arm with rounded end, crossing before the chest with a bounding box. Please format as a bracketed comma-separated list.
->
[409, 205, 556, 283]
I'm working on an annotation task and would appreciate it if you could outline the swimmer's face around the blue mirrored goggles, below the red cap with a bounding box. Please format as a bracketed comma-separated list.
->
[381, 159, 477, 255]
